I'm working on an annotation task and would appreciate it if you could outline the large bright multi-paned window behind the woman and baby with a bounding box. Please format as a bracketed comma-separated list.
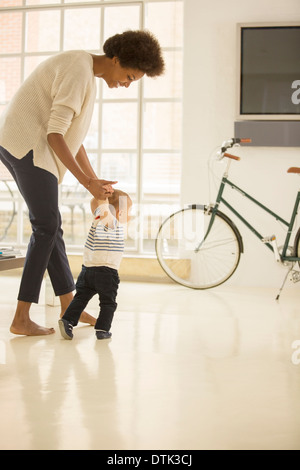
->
[0, 0, 183, 256]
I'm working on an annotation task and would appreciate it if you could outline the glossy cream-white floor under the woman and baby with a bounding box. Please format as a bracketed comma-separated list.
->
[0, 276, 300, 450]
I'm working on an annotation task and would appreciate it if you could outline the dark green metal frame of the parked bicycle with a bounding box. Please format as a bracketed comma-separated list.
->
[210, 161, 300, 262]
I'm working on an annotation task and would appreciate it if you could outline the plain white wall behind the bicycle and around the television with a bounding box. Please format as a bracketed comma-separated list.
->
[182, 0, 300, 289]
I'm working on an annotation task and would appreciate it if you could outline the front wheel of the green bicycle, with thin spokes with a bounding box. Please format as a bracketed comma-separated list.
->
[155, 206, 243, 289]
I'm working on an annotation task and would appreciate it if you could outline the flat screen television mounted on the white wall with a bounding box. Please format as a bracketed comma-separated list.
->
[237, 22, 300, 120]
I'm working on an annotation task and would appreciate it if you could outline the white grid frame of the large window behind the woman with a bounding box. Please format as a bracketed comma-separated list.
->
[0, 0, 183, 256]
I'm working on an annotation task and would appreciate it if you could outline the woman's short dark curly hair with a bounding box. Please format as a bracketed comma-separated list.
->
[103, 30, 165, 77]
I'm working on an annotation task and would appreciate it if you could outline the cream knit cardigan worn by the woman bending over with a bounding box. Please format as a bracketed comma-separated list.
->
[0, 51, 96, 183]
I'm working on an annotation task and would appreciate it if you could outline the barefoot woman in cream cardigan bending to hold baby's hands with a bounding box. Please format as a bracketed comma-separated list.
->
[0, 31, 164, 336]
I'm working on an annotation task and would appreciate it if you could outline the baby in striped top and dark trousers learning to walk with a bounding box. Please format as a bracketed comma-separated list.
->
[58, 189, 132, 340]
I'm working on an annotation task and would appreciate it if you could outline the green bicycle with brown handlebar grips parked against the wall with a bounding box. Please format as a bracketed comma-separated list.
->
[156, 139, 300, 298]
